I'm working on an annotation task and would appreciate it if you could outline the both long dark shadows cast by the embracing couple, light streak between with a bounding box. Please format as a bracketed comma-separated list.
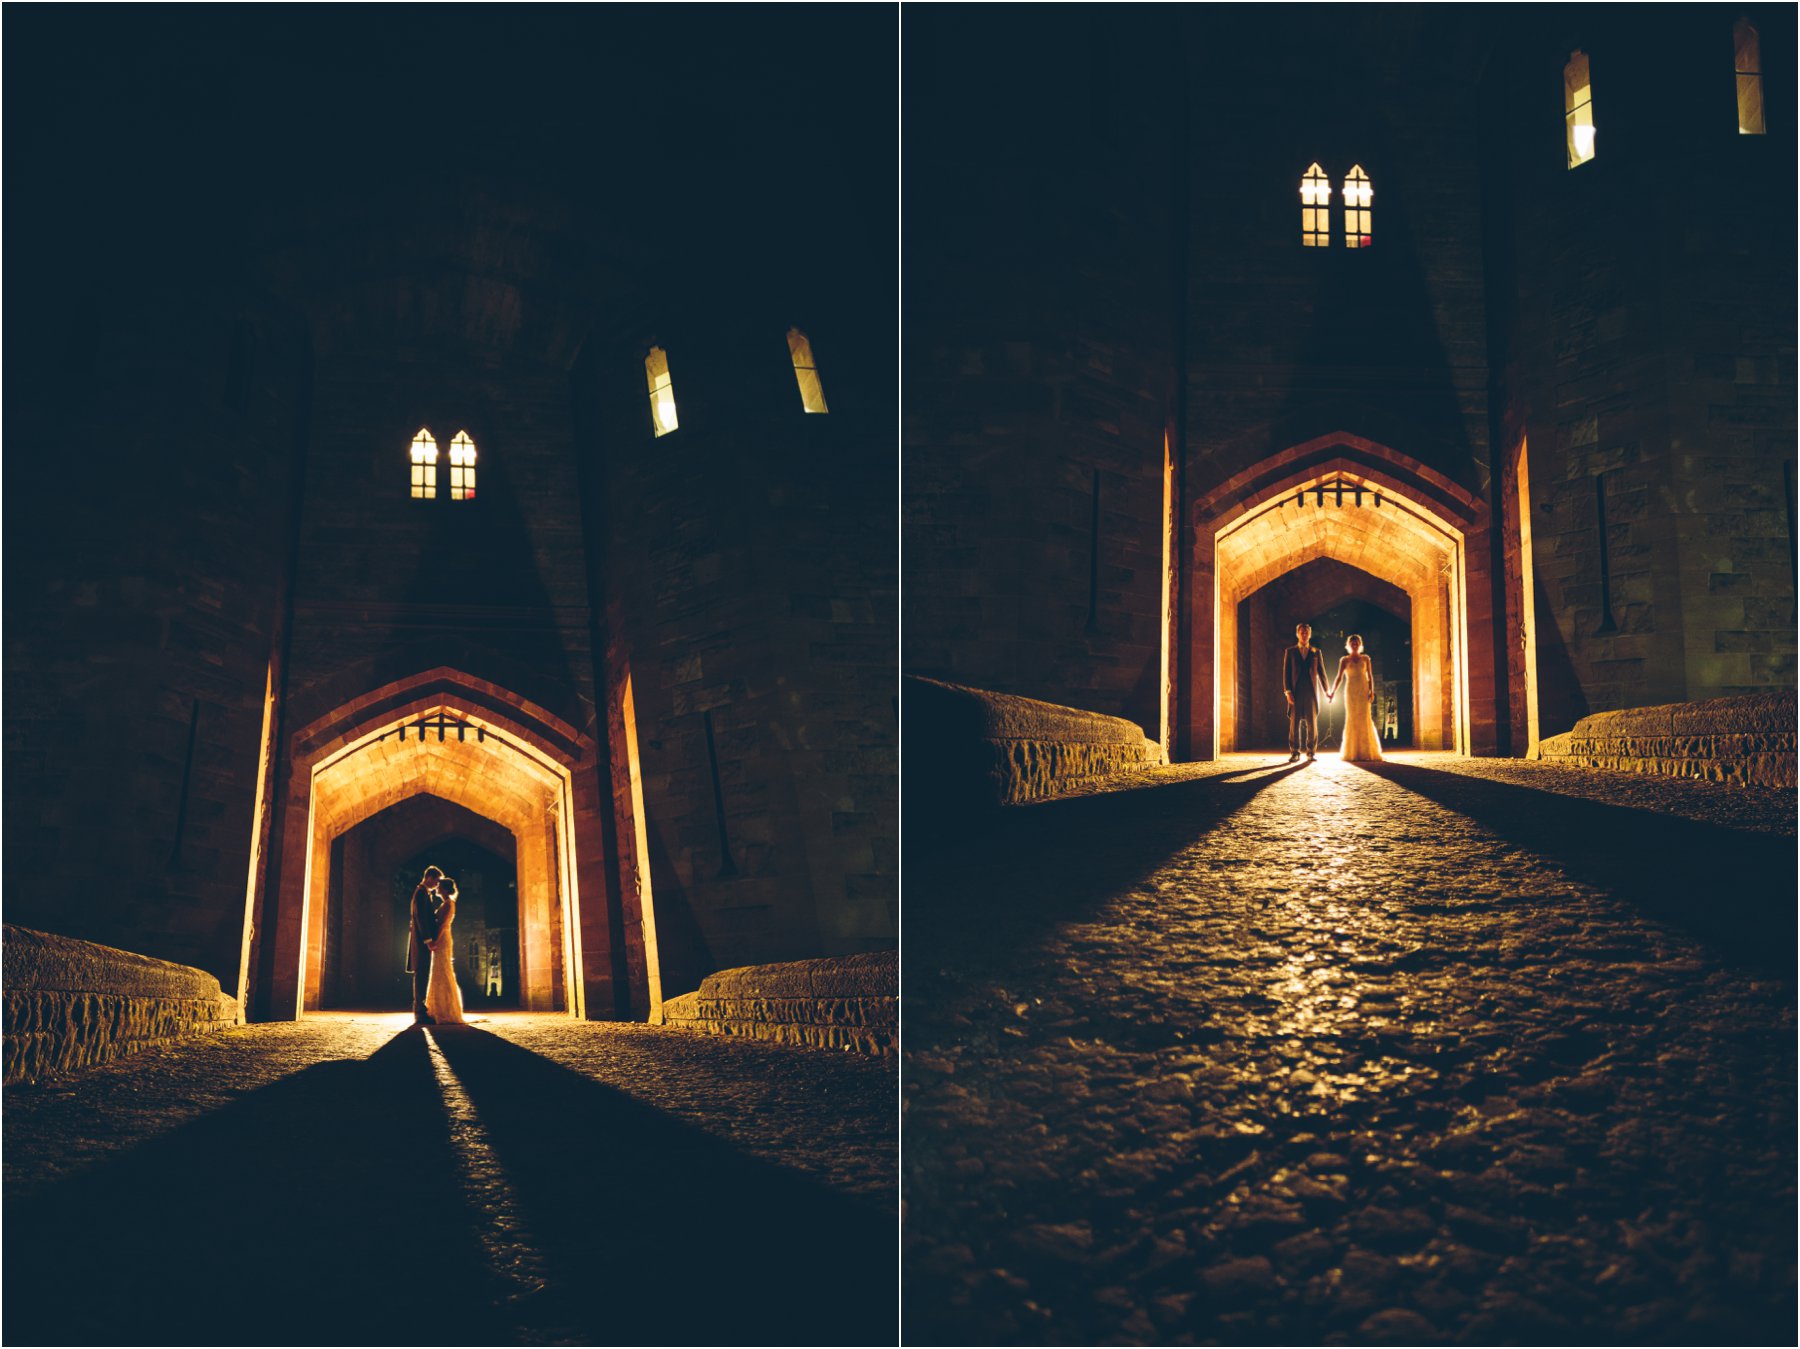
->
[4, 1028, 896, 1345]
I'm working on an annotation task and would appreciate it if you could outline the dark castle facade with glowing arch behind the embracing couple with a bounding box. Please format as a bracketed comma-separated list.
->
[5, 9, 896, 1018]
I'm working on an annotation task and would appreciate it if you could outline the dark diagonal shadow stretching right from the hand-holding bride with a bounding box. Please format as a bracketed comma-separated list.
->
[1357, 764, 1800, 978]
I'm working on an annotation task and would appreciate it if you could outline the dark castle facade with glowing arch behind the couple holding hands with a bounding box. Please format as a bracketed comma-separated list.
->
[904, 7, 1795, 758]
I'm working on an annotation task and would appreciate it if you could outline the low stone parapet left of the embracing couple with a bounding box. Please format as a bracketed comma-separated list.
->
[0, 924, 243, 1082]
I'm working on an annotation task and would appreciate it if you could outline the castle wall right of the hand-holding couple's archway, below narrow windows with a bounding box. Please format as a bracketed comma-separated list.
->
[1489, 9, 1795, 727]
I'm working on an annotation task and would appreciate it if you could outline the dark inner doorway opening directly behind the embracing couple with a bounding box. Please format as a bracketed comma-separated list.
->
[320, 794, 520, 1010]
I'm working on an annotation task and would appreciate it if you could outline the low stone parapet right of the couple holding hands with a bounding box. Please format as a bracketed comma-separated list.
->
[1541, 692, 1795, 787]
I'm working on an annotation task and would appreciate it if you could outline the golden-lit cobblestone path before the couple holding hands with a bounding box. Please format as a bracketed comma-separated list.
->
[902, 755, 1796, 1344]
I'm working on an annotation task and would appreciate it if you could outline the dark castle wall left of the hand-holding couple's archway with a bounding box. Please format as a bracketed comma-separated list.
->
[902, 11, 1181, 738]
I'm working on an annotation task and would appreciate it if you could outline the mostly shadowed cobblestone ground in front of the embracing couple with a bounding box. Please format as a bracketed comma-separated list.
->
[0, 1014, 896, 1345]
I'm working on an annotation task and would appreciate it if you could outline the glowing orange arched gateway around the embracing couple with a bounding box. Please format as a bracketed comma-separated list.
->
[247, 668, 657, 1019]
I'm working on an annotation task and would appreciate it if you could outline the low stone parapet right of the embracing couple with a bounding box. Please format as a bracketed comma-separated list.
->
[662, 951, 900, 1054]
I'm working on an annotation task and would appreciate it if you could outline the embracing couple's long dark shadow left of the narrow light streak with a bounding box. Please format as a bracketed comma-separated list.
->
[4, 1032, 506, 1345]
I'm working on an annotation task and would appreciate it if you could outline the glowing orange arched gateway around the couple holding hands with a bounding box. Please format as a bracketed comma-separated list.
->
[1186, 432, 1494, 758]
